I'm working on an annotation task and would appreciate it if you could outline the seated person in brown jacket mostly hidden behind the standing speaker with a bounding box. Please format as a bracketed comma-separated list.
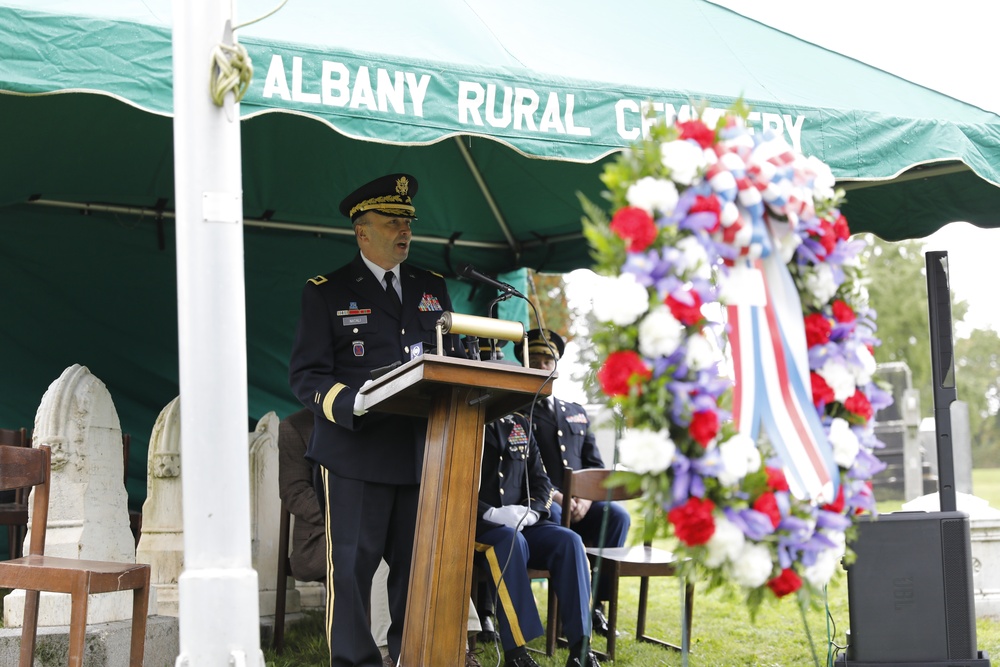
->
[278, 408, 480, 667]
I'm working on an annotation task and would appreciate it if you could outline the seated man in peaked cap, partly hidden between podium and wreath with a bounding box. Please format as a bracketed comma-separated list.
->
[514, 329, 631, 636]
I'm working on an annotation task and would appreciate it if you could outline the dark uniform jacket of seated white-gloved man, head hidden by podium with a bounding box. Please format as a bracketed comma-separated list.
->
[477, 413, 552, 532]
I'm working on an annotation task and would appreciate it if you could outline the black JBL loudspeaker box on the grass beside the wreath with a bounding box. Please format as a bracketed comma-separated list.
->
[838, 512, 990, 667]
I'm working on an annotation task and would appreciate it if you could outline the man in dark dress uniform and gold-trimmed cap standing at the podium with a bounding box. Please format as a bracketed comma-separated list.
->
[289, 174, 464, 667]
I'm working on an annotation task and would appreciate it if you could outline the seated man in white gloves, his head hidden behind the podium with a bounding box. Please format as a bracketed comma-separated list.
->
[476, 360, 600, 667]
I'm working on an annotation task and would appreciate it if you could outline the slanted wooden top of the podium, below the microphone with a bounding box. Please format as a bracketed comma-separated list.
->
[361, 354, 557, 422]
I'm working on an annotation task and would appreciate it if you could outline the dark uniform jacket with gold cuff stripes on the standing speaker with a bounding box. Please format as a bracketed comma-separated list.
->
[289, 253, 465, 484]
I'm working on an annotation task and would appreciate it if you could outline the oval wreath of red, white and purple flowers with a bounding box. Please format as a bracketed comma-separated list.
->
[583, 105, 891, 613]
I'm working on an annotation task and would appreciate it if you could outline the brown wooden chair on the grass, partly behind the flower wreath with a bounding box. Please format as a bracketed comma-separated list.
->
[560, 468, 694, 661]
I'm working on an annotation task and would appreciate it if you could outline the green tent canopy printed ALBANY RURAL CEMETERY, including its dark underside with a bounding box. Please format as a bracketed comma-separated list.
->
[0, 0, 1000, 508]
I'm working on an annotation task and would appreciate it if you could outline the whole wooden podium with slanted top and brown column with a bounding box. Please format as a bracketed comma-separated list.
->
[364, 354, 552, 667]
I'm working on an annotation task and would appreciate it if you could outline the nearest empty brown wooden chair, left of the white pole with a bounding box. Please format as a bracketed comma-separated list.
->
[0, 445, 149, 667]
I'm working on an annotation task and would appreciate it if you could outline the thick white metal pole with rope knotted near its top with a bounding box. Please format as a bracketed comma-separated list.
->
[173, 0, 264, 667]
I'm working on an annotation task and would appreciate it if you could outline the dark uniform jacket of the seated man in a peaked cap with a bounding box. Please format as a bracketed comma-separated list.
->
[533, 398, 604, 490]
